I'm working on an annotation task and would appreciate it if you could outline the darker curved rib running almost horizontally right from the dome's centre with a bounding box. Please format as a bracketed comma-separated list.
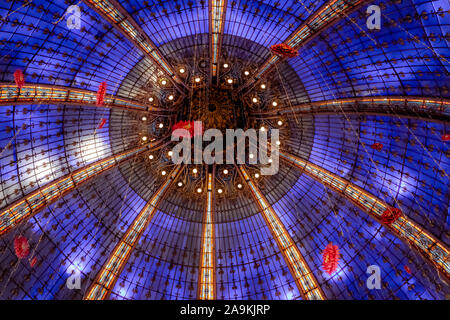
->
[251, 96, 450, 121]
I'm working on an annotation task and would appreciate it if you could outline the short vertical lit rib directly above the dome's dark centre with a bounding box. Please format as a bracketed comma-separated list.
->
[209, 0, 227, 83]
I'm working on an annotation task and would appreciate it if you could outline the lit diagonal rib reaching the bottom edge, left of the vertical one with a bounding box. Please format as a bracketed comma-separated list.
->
[84, 166, 182, 300]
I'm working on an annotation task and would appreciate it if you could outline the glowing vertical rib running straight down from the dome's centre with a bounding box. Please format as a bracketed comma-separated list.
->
[197, 168, 216, 300]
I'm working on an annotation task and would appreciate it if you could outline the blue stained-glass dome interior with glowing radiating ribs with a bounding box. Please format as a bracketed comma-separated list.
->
[0, 0, 450, 300]
